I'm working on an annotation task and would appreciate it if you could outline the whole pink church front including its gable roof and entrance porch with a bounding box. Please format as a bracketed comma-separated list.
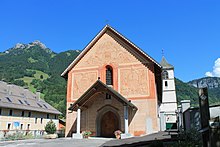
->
[61, 25, 176, 137]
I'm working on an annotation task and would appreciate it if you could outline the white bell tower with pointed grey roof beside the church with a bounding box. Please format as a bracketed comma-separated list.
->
[160, 56, 177, 131]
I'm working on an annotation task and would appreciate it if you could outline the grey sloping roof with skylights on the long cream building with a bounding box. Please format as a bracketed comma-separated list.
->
[0, 81, 62, 114]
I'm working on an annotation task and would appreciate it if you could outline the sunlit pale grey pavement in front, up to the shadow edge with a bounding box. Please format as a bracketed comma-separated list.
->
[0, 138, 110, 147]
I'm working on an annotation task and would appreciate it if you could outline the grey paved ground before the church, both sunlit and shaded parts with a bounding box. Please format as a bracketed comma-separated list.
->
[0, 132, 173, 147]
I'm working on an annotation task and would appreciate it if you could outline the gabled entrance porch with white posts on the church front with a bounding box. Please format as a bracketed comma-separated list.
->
[68, 80, 137, 138]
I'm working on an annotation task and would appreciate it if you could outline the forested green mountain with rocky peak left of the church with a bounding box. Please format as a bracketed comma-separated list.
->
[0, 41, 80, 116]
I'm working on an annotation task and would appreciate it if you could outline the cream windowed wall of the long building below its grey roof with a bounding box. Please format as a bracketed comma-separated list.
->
[0, 108, 59, 130]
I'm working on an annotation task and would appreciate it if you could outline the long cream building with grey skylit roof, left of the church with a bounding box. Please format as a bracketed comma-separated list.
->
[0, 81, 61, 138]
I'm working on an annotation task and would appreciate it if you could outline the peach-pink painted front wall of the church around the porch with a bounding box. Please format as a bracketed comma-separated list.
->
[66, 31, 158, 135]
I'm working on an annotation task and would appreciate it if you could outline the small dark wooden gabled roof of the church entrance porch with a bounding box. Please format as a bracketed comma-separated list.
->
[68, 80, 137, 111]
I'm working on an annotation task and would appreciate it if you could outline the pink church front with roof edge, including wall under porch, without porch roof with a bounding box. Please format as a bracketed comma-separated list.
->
[62, 26, 160, 136]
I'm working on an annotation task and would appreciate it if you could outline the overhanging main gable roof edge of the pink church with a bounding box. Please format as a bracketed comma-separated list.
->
[61, 25, 161, 77]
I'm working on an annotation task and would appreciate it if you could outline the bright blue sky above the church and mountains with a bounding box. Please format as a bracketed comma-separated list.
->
[0, 0, 220, 82]
